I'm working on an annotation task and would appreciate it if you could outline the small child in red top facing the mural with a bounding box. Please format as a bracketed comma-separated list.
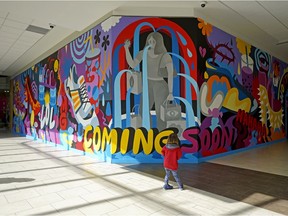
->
[161, 133, 183, 190]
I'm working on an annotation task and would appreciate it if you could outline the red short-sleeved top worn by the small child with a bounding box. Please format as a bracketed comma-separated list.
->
[161, 144, 182, 170]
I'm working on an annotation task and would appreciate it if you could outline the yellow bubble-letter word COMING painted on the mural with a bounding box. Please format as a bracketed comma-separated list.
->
[83, 125, 173, 155]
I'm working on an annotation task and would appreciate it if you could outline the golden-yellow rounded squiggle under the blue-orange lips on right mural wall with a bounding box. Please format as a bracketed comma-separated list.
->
[223, 88, 251, 112]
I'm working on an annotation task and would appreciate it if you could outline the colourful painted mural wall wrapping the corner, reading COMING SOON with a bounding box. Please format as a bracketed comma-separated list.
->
[13, 16, 288, 163]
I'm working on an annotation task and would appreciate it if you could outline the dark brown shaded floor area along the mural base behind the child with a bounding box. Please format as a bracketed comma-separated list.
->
[126, 162, 288, 215]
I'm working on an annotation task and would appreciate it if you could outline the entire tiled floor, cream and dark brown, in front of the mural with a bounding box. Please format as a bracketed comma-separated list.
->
[0, 131, 288, 216]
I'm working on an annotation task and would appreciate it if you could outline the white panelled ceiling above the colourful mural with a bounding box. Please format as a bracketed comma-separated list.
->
[0, 0, 288, 80]
